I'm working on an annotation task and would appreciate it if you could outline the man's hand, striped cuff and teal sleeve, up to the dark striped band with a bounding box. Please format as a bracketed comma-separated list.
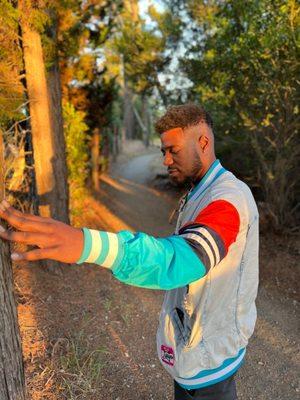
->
[0, 200, 205, 290]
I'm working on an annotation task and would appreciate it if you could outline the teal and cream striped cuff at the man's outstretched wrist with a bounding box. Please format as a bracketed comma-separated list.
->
[77, 228, 124, 269]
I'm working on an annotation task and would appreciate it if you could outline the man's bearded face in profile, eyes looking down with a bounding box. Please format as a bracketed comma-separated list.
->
[160, 128, 202, 184]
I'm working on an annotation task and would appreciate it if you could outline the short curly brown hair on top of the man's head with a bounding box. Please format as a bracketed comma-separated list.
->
[155, 103, 213, 135]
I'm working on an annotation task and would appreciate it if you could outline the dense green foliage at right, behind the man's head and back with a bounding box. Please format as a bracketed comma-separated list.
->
[161, 0, 300, 230]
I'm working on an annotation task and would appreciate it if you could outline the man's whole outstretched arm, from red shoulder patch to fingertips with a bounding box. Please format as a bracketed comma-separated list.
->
[0, 200, 240, 290]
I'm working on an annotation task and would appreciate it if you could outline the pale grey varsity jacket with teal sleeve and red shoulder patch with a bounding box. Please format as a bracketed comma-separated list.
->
[78, 160, 258, 389]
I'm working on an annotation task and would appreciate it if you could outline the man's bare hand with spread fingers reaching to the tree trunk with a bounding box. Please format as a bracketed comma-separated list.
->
[0, 200, 84, 263]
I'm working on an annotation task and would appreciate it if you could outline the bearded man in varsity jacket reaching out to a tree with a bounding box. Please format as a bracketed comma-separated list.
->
[0, 104, 258, 400]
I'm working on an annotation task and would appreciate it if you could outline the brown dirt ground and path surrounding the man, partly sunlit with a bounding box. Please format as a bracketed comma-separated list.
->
[14, 148, 300, 400]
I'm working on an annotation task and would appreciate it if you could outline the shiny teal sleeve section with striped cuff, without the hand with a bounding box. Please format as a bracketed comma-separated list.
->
[77, 228, 206, 290]
